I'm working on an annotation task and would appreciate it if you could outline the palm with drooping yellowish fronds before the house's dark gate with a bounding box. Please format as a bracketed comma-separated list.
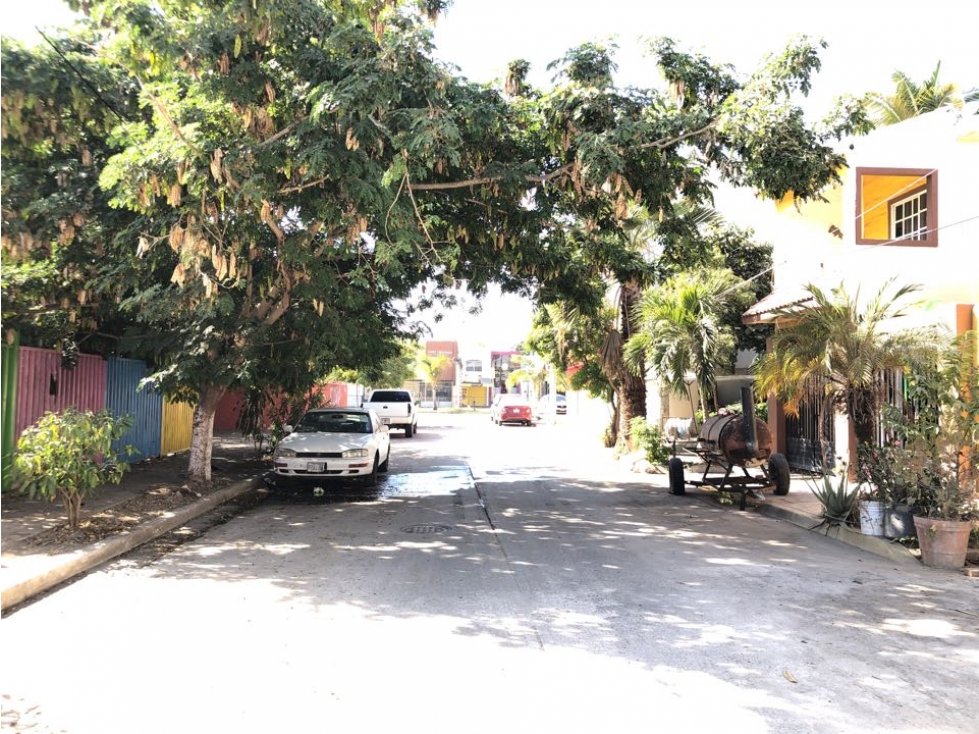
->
[756, 280, 925, 460]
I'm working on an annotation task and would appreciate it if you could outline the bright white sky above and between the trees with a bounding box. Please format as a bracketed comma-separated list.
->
[0, 0, 979, 356]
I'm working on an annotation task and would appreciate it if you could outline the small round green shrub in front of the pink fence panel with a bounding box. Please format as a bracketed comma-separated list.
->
[13, 408, 133, 528]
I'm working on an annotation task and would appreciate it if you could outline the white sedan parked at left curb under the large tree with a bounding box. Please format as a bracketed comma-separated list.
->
[272, 408, 391, 485]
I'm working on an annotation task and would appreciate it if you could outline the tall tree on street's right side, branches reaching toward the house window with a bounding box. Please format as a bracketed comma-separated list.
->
[508, 39, 866, 452]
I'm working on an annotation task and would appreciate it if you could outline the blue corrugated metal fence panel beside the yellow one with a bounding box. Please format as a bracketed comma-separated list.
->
[105, 357, 163, 461]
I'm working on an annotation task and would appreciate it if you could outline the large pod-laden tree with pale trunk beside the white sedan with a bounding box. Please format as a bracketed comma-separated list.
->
[4, 0, 535, 481]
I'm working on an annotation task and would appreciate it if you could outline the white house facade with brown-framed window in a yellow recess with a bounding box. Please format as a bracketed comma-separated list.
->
[743, 103, 979, 468]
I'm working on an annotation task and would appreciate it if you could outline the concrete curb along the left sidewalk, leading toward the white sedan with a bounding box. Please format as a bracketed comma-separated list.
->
[0, 477, 261, 611]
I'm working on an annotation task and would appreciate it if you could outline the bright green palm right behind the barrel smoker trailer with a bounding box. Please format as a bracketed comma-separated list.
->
[626, 268, 751, 428]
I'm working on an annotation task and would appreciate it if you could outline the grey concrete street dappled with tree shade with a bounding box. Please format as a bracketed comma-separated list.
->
[0, 413, 979, 734]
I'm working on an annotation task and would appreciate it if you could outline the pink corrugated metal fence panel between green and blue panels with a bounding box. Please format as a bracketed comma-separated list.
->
[14, 347, 106, 441]
